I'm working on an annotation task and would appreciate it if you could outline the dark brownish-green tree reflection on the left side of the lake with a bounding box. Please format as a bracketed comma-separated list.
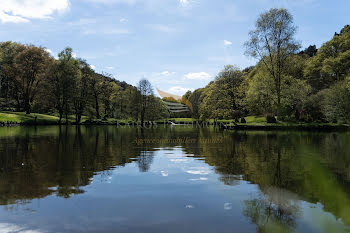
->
[0, 127, 146, 205]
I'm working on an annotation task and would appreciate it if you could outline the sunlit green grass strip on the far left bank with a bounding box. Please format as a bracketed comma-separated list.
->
[0, 112, 58, 124]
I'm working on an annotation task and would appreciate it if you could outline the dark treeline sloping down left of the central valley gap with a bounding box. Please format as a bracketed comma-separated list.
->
[0, 42, 167, 123]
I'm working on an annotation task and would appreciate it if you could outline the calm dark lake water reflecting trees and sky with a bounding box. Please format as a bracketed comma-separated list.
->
[0, 126, 350, 233]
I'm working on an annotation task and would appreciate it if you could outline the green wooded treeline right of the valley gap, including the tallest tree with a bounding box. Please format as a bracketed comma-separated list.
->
[183, 9, 350, 122]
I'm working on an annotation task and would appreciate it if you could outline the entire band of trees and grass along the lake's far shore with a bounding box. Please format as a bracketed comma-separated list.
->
[0, 9, 350, 125]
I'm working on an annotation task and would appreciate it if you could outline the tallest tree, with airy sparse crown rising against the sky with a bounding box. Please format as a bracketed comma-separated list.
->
[245, 8, 300, 117]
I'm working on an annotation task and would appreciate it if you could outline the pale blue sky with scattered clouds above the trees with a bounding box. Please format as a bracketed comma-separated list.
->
[0, 0, 350, 94]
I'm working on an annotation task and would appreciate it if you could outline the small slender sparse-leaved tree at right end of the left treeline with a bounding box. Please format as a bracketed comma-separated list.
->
[137, 79, 153, 125]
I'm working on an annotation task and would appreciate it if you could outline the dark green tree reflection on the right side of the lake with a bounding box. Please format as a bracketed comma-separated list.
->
[186, 132, 350, 229]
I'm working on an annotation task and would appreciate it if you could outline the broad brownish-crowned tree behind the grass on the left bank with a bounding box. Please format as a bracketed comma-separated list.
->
[15, 45, 50, 114]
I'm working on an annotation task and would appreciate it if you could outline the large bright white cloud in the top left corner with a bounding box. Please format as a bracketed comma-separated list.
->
[0, 0, 69, 23]
